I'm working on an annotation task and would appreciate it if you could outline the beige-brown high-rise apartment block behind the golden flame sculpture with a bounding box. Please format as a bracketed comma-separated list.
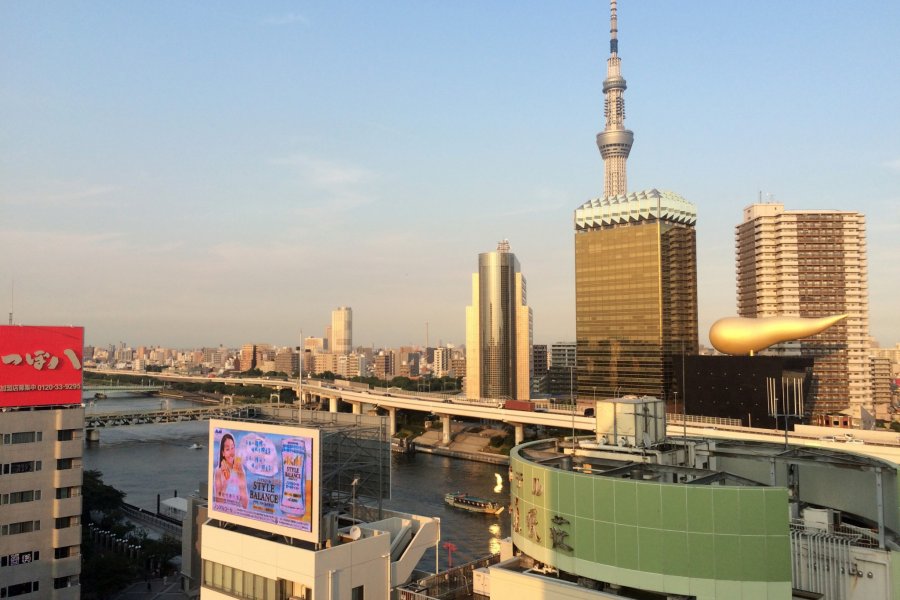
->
[735, 203, 872, 414]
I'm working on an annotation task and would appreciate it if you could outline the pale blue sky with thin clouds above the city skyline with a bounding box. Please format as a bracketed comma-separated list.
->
[0, 0, 900, 347]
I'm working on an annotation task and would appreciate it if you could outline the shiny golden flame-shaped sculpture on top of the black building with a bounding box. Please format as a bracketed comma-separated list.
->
[709, 315, 847, 356]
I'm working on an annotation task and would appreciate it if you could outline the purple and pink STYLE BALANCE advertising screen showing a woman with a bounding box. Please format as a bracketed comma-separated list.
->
[208, 420, 321, 542]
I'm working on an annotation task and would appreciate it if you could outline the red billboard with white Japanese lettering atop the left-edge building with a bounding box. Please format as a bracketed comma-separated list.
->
[0, 325, 84, 407]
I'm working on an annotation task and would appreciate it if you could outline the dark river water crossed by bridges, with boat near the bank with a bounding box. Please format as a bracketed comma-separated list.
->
[84, 395, 510, 569]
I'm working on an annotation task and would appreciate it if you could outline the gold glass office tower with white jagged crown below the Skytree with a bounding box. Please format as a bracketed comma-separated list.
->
[575, 190, 698, 399]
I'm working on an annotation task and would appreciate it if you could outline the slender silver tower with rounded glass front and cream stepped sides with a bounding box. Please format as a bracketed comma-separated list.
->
[466, 240, 532, 400]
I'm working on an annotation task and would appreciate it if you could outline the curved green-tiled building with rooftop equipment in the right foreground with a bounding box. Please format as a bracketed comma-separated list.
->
[490, 399, 900, 600]
